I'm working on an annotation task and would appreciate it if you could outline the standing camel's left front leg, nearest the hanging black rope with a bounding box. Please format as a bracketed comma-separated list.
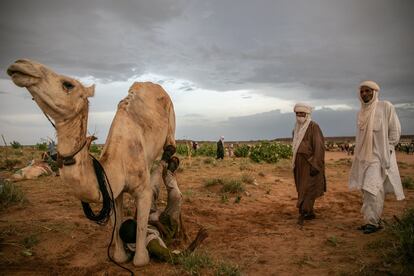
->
[111, 193, 128, 263]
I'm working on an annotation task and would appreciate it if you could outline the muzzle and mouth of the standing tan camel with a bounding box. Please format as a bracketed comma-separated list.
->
[7, 60, 40, 87]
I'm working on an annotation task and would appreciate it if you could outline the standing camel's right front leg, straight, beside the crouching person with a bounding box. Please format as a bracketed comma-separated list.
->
[134, 177, 152, 266]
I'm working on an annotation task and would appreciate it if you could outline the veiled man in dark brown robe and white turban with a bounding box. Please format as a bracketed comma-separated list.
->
[292, 103, 326, 225]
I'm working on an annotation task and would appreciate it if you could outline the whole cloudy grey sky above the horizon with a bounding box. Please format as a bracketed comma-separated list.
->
[0, 0, 414, 144]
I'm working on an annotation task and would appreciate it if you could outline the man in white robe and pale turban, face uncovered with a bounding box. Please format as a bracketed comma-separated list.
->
[349, 81, 404, 234]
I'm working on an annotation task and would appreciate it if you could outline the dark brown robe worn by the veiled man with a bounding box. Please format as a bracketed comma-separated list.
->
[293, 121, 326, 208]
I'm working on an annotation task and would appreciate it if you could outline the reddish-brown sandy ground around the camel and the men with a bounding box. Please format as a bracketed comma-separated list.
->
[0, 152, 414, 275]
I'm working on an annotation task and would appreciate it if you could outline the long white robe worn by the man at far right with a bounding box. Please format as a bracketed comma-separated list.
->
[349, 101, 405, 200]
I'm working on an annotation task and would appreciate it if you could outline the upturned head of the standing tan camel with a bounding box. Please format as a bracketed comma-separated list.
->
[7, 59, 95, 121]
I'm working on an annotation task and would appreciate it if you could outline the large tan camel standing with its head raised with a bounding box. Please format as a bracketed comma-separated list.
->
[7, 59, 176, 266]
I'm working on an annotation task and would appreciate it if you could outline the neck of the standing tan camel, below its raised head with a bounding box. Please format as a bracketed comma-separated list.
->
[56, 105, 102, 202]
